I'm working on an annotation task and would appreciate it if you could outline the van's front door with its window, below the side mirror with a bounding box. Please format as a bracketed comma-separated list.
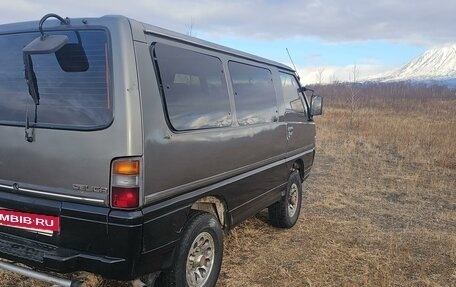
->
[280, 72, 315, 170]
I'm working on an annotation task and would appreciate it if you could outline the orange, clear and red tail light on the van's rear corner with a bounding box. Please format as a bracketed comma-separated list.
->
[111, 158, 142, 209]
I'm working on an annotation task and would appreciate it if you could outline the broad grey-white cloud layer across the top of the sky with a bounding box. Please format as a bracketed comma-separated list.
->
[0, 0, 456, 44]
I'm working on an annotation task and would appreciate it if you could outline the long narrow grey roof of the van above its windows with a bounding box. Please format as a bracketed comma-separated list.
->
[0, 15, 294, 72]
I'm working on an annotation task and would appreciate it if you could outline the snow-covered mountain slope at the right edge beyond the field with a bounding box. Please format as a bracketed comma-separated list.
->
[375, 44, 456, 83]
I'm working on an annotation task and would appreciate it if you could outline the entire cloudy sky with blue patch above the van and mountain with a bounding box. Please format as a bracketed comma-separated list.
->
[0, 0, 456, 84]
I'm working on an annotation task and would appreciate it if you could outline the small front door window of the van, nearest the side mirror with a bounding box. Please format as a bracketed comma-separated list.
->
[280, 73, 306, 113]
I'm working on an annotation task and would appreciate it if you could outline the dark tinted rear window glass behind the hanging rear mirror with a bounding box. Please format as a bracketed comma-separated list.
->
[0, 30, 112, 129]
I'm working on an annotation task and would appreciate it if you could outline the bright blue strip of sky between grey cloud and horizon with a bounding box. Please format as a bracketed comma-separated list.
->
[205, 36, 427, 82]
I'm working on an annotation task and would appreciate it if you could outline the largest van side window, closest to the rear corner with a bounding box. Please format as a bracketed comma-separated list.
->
[153, 43, 232, 130]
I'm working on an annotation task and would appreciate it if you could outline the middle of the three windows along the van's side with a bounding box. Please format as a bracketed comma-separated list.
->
[228, 62, 277, 125]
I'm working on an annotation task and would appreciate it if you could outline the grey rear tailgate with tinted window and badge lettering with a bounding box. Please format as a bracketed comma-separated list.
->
[0, 29, 113, 208]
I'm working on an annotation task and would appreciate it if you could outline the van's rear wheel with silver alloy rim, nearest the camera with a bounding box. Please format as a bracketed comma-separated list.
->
[155, 213, 223, 287]
